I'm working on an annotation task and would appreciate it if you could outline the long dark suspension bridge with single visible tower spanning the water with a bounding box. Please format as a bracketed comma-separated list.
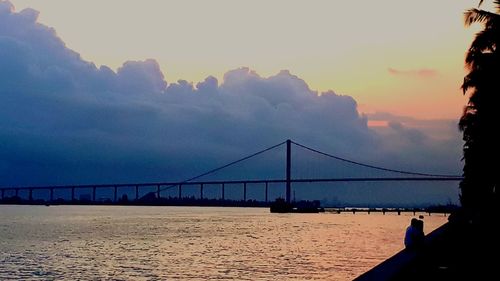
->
[0, 140, 462, 203]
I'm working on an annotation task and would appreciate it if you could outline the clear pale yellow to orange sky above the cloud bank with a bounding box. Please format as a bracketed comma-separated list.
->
[7, 0, 477, 119]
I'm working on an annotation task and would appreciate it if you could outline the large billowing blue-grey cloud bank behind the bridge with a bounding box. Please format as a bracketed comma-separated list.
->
[0, 1, 460, 205]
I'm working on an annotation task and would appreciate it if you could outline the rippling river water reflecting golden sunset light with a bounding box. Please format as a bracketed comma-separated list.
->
[0, 206, 446, 280]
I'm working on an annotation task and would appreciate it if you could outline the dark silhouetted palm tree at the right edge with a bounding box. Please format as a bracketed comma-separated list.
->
[459, 0, 500, 210]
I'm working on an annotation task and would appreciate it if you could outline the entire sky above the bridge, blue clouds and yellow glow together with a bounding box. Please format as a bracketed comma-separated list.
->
[0, 0, 477, 205]
